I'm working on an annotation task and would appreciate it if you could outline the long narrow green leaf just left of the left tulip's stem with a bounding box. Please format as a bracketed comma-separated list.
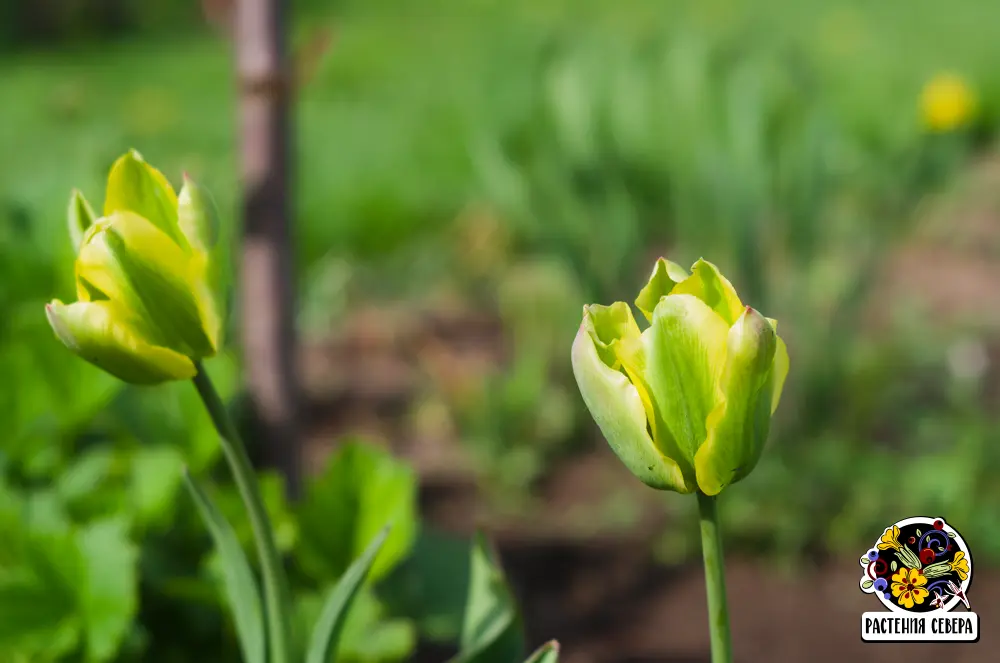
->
[184, 470, 266, 663]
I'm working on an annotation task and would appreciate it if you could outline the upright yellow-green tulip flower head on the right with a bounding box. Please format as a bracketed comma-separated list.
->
[572, 258, 788, 495]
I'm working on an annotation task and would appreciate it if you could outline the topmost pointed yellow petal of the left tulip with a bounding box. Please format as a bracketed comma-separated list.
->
[104, 150, 187, 248]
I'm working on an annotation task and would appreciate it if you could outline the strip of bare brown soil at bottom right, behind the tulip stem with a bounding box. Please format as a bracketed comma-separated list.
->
[505, 551, 1000, 663]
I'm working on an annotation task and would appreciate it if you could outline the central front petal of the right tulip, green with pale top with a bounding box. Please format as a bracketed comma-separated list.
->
[643, 294, 729, 465]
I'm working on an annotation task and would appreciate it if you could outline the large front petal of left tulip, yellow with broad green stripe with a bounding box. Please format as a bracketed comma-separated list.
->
[76, 212, 220, 358]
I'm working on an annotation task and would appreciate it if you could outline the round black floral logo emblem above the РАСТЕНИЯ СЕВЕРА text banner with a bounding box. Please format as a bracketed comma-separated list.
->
[860, 517, 972, 613]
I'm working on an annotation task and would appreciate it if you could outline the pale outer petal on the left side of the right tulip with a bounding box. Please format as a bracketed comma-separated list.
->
[572, 323, 691, 493]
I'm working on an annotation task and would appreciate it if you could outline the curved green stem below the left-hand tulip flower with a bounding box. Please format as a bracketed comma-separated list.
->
[194, 362, 293, 663]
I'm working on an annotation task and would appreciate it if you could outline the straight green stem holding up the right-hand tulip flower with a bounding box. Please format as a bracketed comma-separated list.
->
[698, 491, 733, 663]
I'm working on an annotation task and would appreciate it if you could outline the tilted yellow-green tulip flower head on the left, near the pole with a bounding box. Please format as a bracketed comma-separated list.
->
[45, 151, 222, 384]
